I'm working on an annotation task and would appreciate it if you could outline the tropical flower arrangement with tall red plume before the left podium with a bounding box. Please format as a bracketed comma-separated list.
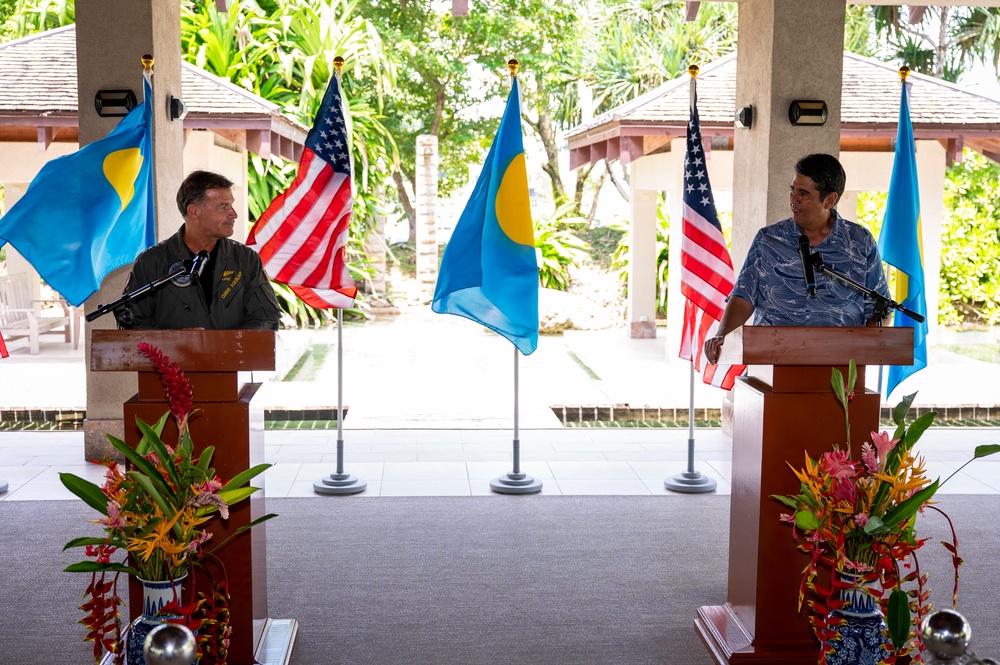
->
[60, 342, 274, 663]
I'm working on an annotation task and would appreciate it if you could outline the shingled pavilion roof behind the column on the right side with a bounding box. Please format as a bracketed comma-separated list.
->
[566, 53, 1000, 168]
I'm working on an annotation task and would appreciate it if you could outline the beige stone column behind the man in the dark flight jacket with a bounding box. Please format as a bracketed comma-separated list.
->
[76, 0, 184, 459]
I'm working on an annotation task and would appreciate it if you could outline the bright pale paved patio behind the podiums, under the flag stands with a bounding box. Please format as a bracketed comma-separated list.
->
[0, 313, 1000, 501]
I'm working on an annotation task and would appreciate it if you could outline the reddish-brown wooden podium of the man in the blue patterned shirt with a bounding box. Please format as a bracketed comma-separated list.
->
[694, 326, 913, 665]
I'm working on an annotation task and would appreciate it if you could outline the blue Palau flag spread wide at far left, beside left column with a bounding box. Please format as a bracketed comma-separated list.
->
[0, 67, 156, 306]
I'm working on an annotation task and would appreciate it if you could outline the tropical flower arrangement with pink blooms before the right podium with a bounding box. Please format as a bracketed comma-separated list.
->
[774, 360, 1000, 663]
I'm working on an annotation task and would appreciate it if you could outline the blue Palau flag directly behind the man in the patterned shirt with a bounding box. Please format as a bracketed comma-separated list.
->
[878, 75, 927, 397]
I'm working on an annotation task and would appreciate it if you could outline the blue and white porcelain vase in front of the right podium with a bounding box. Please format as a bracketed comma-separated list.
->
[826, 571, 892, 665]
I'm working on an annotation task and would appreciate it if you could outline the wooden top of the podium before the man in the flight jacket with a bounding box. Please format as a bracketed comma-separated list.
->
[90, 330, 276, 372]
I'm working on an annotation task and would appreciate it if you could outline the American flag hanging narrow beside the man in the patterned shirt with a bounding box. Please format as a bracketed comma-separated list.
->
[680, 88, 744, 390]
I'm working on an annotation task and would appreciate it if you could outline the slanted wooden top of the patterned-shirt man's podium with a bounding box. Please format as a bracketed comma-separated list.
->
[719, 326, 913, 367]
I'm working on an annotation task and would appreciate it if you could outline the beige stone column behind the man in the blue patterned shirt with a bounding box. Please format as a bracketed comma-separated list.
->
[732, 0, 846, 262]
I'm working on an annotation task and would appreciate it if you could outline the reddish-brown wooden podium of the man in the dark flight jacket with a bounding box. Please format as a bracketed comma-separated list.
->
[90, 330, 296, 665]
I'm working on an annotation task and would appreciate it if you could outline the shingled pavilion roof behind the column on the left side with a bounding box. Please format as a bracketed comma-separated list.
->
[0, 25, 309, 159]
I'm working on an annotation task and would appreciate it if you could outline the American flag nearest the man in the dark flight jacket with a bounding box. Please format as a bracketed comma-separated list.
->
[247, 71, 358, 308]
